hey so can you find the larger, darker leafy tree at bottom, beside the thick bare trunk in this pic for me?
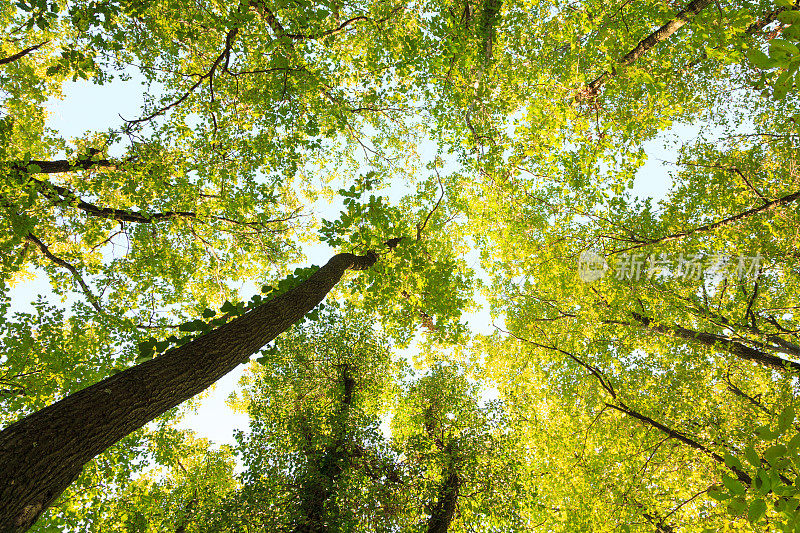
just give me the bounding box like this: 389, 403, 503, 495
214, 311, 405, 531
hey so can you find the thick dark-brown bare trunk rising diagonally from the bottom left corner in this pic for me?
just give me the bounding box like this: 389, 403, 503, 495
0, 252, 377, 533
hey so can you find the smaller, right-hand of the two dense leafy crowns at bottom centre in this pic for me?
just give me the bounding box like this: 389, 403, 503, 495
391, 366, 538, 531
